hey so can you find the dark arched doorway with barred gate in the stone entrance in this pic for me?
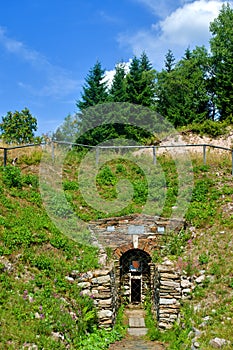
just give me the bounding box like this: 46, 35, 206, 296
120, 249, 152, 304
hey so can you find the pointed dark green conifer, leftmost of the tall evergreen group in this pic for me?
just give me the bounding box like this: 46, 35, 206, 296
76, 61, 108, 112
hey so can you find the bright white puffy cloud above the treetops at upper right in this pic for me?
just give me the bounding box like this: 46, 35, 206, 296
118, 0, 231, 69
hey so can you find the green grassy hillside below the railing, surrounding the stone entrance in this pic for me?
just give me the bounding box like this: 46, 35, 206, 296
0, 146, 233, 350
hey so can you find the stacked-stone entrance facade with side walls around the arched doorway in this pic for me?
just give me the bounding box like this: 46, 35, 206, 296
68, 215, 193, 329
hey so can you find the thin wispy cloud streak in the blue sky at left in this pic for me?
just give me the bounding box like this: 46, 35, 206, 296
0, 27, 80, 98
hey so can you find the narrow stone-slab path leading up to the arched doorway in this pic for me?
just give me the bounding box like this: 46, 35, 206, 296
109, 306, 166, 350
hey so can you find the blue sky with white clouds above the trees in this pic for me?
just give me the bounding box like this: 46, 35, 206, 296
0, 0, 232, 135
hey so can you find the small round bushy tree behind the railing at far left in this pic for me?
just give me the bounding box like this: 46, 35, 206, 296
0, 108, 37, 144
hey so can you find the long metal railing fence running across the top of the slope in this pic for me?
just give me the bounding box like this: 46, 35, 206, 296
0, 141, 233, 176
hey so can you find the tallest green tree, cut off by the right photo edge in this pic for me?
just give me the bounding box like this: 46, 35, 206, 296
210, 3, 233, 120
